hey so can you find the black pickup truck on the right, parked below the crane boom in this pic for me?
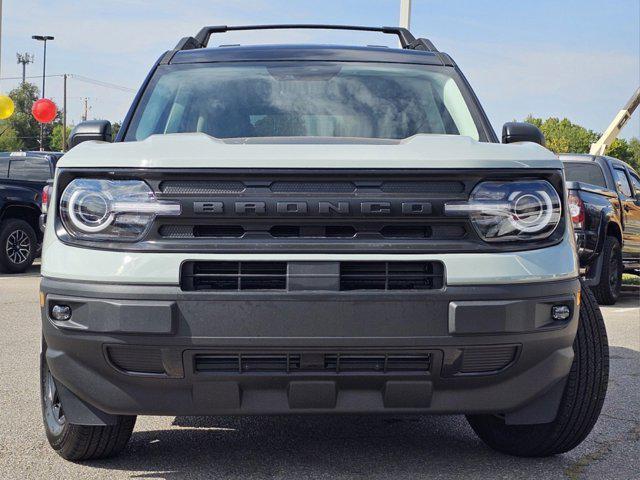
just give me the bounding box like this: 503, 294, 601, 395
560, 155, 640, 305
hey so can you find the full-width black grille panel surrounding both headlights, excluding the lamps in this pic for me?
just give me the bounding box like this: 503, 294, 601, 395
56, 168, 566, 254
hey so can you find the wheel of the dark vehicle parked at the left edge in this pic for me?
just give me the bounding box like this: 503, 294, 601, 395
0, 218, 38, 273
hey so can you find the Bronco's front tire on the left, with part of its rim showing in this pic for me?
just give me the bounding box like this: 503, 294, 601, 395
40, 354, 136, 461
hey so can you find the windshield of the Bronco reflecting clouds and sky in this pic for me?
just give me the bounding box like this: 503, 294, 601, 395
125, 62, 479, 140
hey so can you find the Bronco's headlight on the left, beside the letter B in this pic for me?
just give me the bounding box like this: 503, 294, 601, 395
60, 178, 180, 241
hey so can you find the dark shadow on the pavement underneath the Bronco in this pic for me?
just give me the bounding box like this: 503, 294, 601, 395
82, 416, 561, 479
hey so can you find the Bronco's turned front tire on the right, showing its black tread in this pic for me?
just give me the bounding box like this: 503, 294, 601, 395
467, 285, 609, 457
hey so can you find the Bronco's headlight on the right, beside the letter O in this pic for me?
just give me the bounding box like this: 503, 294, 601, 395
445, 180, 562, 242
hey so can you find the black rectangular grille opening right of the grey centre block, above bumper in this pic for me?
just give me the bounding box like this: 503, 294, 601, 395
340, 262, 444, 290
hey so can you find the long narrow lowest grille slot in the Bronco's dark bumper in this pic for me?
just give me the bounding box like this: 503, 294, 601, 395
194, 353, 431, 374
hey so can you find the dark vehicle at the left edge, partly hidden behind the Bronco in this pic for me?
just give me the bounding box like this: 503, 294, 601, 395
0, 152, 62, 273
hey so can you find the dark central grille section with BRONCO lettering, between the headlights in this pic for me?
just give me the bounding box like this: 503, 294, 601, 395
149, 170, 480, 253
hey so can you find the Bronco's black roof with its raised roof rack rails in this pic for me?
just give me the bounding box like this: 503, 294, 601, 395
160, 24, 455, 66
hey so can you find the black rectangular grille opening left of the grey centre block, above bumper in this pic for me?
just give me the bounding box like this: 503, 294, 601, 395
180, 262, 287, 291
